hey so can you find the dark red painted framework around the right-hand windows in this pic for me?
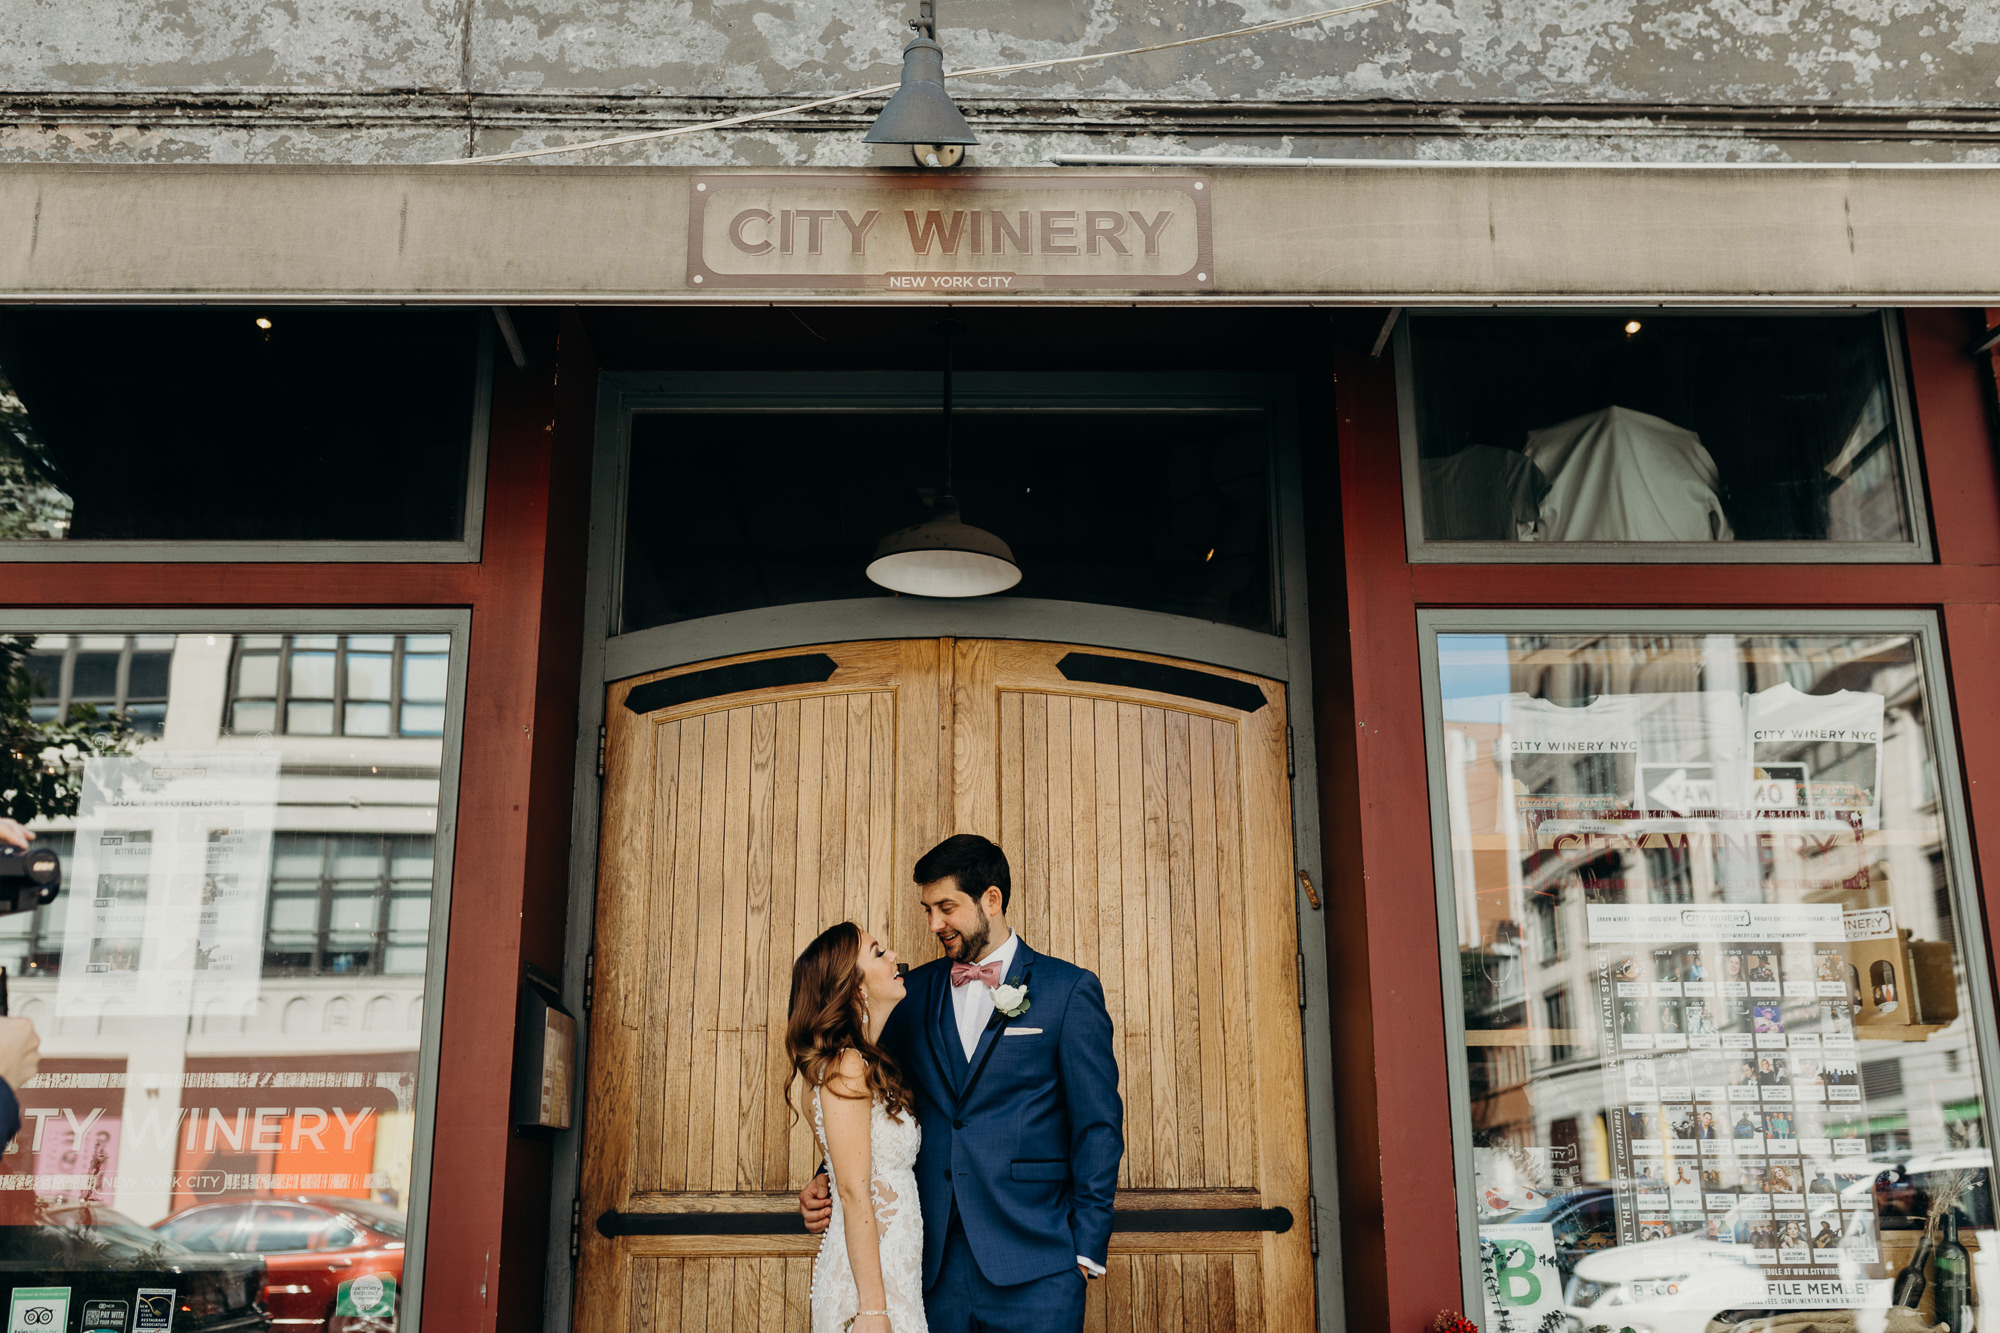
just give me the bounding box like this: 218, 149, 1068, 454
1314, 310, 2000, 1333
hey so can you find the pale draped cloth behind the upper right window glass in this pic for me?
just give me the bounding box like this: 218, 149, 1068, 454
1522, 406, 1736, 542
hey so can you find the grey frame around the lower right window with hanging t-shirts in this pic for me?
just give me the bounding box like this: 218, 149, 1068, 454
1416, 606, 2000, 1309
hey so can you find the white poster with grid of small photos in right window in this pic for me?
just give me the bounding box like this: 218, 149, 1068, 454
1586, 903, 1888, 1309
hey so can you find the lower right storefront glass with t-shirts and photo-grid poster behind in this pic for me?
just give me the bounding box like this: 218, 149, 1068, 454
1430, 612, 2000, 1331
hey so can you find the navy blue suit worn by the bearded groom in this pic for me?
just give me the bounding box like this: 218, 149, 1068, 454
882, 928, 1124, 1329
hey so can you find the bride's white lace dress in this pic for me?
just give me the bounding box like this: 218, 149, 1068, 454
812, 1089, 928, 1333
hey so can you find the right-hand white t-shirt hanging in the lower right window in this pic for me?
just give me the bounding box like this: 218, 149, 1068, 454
1744, 683, 1886, 827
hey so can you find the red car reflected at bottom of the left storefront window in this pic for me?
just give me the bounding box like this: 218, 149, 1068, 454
154, 1195, 402, 1333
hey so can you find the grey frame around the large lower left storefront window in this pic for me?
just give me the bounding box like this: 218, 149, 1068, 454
0, 606, 472, 1309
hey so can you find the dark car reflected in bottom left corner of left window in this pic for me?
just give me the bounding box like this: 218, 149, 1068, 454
0, 1203, 270, 1333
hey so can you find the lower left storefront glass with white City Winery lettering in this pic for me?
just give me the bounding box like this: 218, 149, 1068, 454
0, 624, 452, 1333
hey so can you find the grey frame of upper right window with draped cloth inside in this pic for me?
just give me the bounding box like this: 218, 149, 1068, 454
1392, 304, 1936, 564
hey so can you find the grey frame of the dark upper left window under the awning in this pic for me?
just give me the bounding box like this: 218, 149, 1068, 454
0, 316, 494, 564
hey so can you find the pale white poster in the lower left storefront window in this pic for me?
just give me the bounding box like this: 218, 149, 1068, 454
56, 753, 278, 1017
